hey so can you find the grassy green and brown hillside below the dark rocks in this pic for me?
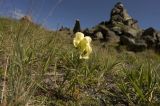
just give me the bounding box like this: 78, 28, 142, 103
0, 18, 160, 106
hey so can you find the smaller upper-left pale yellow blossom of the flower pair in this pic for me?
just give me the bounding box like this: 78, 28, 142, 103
73, 32, 84, 47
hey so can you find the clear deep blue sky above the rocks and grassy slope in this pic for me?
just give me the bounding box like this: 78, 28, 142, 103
0, 0, 160, 30
